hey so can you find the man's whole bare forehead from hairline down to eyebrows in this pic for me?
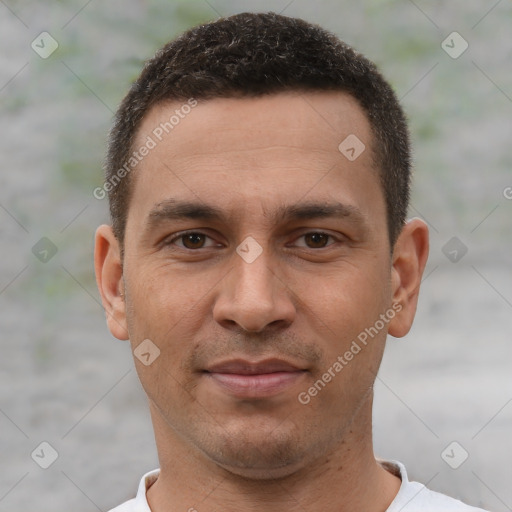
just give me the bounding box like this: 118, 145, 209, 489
129, 92, 382, 234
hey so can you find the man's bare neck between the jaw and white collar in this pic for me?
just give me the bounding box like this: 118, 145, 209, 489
147, 398, 400, 512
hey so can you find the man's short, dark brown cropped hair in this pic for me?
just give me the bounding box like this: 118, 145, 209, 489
105, 12, 411, 247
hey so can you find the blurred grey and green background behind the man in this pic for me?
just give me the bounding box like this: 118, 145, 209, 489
0, 0, 512, 512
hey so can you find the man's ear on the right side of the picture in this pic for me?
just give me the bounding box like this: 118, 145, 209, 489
388, 218, 429, 338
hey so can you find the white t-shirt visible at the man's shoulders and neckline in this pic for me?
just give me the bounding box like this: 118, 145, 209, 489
109, 461, 486, 512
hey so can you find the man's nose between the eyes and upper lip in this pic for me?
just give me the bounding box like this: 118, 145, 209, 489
213, 243, 296, 332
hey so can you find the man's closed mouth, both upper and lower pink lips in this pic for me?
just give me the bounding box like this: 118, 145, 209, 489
204, 359, 306, 398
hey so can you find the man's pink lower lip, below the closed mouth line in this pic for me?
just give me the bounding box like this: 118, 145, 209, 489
207, 371, 304, 398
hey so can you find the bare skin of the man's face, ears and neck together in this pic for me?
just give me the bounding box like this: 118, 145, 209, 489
95, 92, 428, 512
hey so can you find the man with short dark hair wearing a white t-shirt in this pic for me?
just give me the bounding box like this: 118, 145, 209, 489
95, 13, 488, 512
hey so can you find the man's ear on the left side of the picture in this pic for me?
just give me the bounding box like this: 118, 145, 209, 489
94, 224, 129, 340
